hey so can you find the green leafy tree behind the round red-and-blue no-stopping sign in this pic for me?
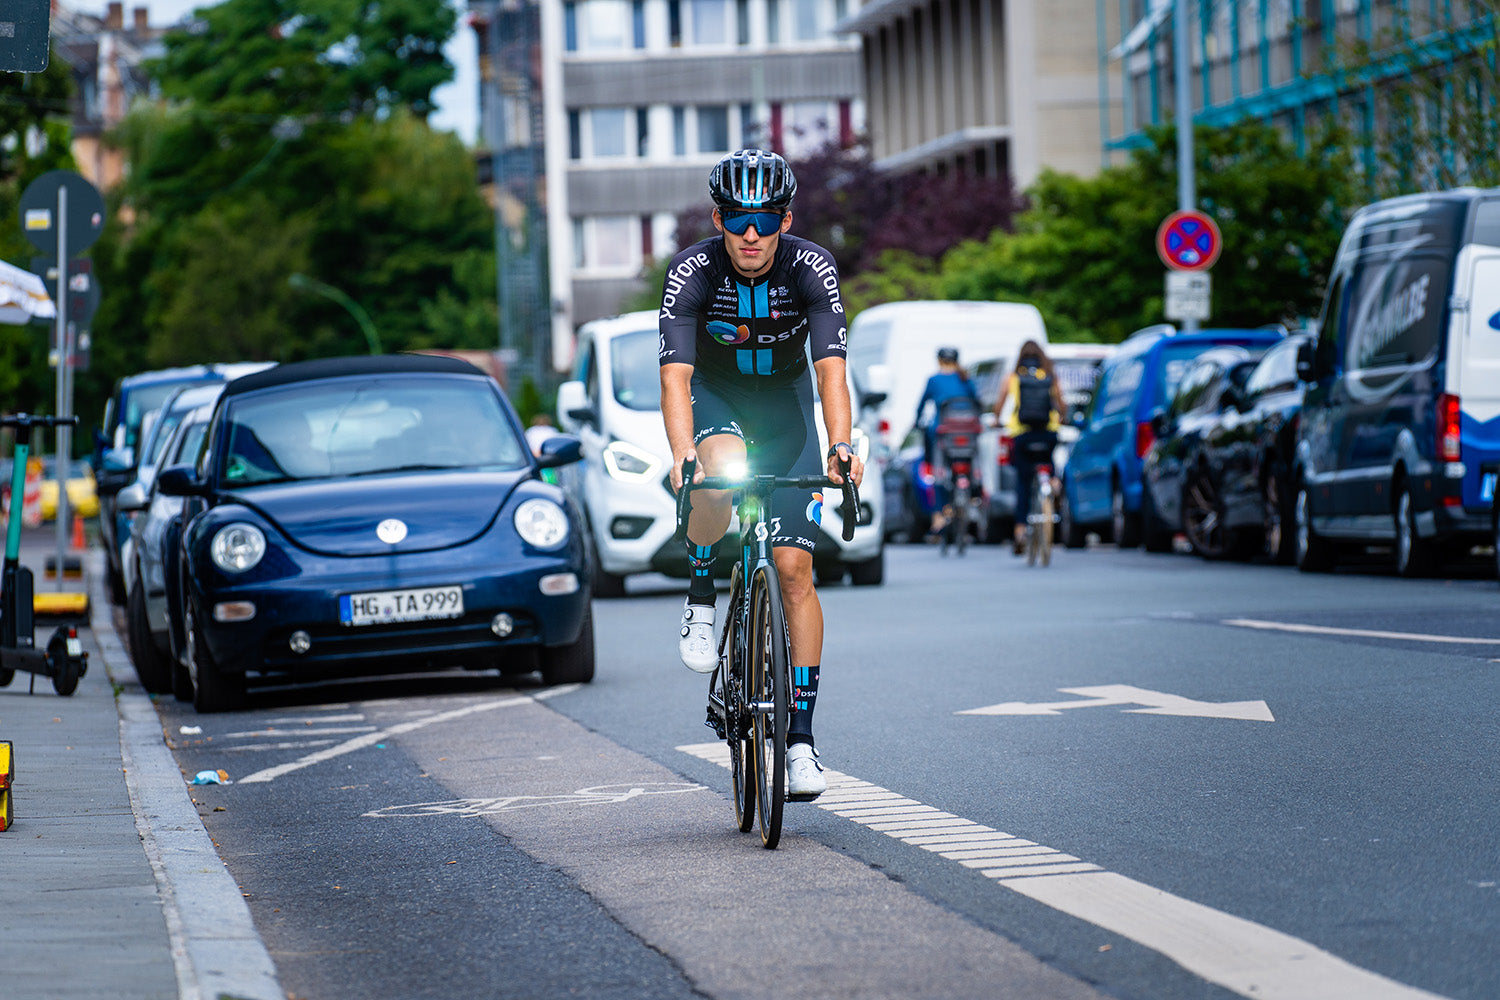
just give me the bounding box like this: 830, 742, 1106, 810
941, 123, 1358, 343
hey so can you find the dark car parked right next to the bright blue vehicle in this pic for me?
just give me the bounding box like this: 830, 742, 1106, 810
1140, 346, 1272, 559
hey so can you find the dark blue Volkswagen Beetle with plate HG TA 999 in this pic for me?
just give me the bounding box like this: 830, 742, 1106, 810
158, 354, 594, 712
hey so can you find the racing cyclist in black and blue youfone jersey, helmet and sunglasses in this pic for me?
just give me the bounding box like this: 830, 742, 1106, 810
660, 150, 864, 798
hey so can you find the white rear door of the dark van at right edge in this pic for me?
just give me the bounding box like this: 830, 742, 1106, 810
1446, 244, 1500, 508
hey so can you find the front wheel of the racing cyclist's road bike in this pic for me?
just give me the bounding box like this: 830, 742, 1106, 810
746, 565, 792, 850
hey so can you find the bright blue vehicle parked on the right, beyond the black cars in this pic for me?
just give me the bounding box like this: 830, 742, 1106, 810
1058, 324, 1286, 549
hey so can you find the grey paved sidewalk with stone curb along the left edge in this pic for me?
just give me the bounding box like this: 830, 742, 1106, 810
0, 528, 285, 1000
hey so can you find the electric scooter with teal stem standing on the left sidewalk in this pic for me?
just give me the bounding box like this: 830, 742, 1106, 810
0, 414, 89, 697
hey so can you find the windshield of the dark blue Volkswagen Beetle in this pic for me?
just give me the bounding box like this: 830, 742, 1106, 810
221, 376, 530, 486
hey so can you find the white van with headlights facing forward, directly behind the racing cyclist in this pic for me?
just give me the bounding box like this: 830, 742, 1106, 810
557, 310, 885, 597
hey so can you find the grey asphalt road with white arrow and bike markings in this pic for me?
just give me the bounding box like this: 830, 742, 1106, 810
149, 546, 1500, 1000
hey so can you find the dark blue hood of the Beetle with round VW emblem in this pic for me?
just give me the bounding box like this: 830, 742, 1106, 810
222, 469, 531, 556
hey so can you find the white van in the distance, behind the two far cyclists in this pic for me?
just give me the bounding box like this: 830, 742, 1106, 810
849, 301, 1047, 540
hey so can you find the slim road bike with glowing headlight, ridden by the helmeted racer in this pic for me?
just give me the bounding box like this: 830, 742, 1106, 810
677, 459, 860, 849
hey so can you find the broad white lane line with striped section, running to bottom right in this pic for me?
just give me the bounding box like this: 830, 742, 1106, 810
678, 741, 1442, 1000
